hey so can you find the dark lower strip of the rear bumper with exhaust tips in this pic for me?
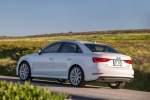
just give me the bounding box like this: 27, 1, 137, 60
97, 76, 133, 82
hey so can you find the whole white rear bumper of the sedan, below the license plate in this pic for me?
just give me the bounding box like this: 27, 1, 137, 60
85, 67, 134, 82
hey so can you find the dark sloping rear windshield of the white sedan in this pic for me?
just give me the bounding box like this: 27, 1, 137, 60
84, 44, 119, 53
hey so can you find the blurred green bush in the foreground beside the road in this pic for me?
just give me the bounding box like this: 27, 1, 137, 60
0, 81, 67, 100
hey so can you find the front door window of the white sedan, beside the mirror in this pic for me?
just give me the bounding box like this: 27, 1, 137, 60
42, 42, 62, 53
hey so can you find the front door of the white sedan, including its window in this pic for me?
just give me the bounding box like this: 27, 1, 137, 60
32, 42, 62, 76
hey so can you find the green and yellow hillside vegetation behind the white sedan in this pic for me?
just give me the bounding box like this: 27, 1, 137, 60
0, 30, 150, 91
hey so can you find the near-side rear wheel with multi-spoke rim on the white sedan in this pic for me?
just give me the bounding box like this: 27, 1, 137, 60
69, 66, 86, 87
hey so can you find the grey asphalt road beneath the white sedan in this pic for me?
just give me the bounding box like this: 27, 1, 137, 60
0, 76, 150, 100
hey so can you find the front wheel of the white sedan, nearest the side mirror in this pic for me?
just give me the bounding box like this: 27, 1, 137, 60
18, 62, 33, 81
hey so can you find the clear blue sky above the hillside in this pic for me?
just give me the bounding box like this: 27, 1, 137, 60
0, 0, 150, 36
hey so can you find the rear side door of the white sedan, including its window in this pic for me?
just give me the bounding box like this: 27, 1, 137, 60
53, 42, 81, 77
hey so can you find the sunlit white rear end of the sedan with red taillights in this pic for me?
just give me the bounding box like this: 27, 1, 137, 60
92, 53, 134, 82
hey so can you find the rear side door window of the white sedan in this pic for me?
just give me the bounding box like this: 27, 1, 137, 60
61, 43, 82, 53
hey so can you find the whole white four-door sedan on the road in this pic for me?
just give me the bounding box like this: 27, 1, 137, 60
16, 40, 134, 89
